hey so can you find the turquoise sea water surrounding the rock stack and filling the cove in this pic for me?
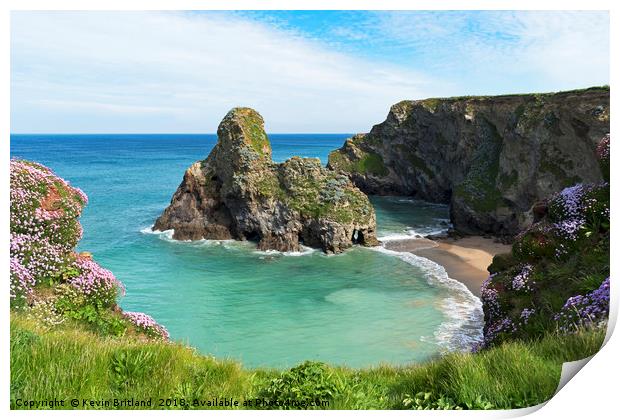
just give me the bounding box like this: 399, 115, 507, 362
11, 134, 481, 367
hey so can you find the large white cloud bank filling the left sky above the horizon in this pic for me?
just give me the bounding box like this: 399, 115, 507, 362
11, 12, 436, 132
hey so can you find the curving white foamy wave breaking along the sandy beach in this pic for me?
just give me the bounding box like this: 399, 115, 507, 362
372, 246, 484, 352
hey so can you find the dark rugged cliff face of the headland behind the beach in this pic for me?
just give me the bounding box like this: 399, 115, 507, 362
328, 87, 609, 235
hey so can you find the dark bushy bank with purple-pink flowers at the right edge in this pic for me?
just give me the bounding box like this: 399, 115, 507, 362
482, 135, 610, 347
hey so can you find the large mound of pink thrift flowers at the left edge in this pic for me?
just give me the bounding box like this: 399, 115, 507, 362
10, 159, 123, 302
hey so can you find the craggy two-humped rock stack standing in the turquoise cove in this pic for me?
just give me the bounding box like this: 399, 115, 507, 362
153, 108, 377, 253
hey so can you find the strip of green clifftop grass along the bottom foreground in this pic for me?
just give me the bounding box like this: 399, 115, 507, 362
11, 313, 604, 409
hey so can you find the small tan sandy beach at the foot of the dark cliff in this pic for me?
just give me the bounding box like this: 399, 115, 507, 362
384, 236, 511, 297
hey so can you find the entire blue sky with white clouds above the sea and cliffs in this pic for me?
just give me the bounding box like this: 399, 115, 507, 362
11, 11, 609, 133
